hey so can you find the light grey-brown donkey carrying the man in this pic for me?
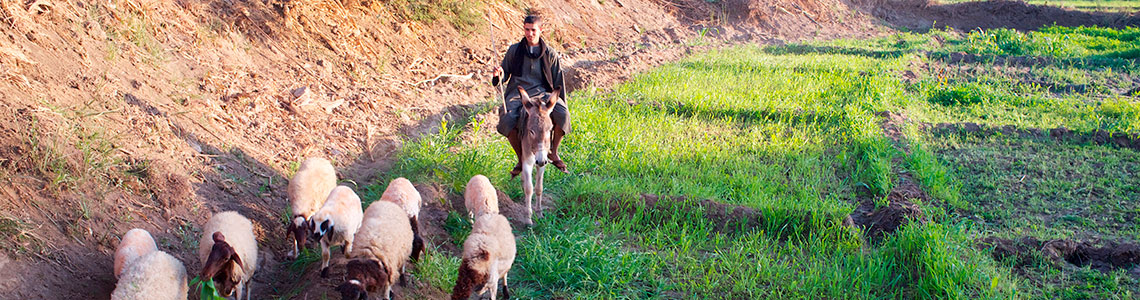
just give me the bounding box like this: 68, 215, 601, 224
519, 87, 562, 226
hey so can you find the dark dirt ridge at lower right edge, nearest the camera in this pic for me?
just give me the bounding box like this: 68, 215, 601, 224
977, 236, 1140, 271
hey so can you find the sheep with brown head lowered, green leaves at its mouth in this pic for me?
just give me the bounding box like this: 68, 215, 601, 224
198, 211, 258, 299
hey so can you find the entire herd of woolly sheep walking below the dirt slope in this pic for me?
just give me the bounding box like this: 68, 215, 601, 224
111, 159, 515, 299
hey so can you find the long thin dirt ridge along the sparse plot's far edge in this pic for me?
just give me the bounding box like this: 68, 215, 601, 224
923, 122, 1140, 151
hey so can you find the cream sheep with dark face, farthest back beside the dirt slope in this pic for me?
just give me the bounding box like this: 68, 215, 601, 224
287, 157, 336, 257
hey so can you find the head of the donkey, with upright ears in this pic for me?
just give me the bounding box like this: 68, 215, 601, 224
519, 87, 561, 167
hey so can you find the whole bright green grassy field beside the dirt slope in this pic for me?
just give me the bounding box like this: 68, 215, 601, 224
363, 27, 1140, 299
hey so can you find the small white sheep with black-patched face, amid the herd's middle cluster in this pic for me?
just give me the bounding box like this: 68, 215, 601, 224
310, 186, 364, 278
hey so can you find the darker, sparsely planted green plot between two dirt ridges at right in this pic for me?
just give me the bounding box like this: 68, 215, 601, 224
931, 135, 1140, 241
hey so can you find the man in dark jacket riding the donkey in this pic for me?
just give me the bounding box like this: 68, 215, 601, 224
492, 15, 570, 178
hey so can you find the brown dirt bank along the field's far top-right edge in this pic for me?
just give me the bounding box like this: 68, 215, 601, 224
855, 0, 1140, 31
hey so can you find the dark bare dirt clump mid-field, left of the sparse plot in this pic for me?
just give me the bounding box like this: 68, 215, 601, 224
845, 175, 930, 241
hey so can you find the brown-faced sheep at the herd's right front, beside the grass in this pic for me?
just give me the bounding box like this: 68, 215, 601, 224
451, 214, 515, 300
